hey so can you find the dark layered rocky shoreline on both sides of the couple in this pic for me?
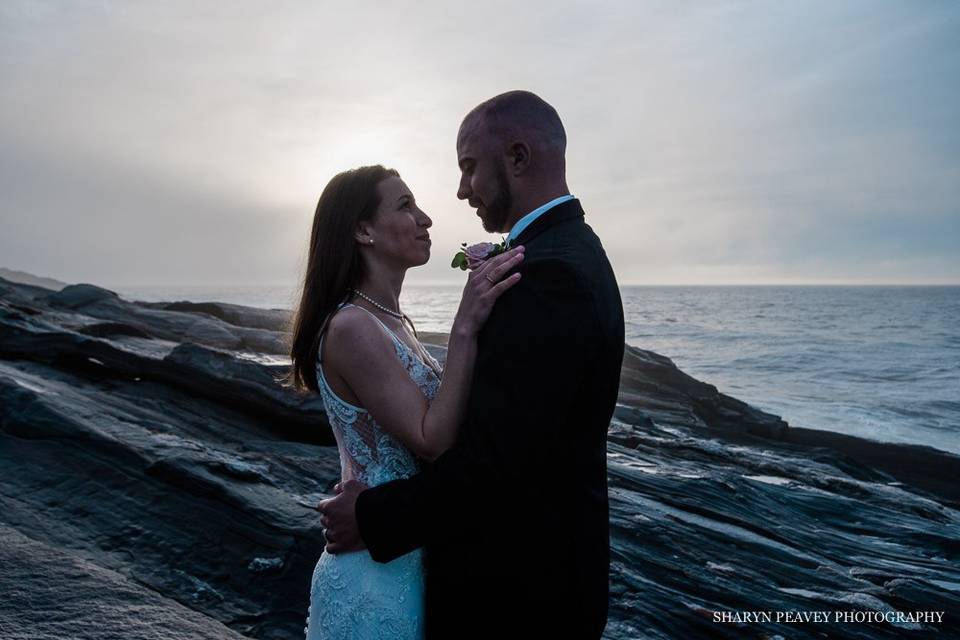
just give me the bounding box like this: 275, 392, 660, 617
0, 279, 960, 639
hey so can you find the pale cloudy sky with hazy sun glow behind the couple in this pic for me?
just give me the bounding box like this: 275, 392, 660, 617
0, 0, 960, 287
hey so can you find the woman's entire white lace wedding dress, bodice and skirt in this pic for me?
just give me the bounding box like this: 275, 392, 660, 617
304, 304, 440, 640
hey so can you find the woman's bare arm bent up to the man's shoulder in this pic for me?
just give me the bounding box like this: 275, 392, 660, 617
324, 247, 523, 460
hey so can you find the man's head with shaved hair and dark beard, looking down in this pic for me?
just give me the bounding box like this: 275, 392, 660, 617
457, 91, 568, 232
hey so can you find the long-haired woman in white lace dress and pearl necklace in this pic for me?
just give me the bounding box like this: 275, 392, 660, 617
291, 165, 523, 640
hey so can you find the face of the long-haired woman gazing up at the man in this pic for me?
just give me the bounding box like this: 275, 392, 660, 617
361, 177, 433, 267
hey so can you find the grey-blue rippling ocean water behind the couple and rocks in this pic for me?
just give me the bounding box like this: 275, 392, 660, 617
118, 285, 960, 454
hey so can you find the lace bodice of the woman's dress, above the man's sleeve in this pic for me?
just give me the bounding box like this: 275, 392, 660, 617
317, 304, 440, 487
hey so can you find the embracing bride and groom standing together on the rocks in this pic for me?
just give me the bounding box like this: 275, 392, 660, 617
291, 91, 624, 640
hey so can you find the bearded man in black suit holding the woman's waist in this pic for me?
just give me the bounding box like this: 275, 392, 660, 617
319, 91, 624, 639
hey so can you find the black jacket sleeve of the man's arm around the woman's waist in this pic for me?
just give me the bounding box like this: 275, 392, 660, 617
355, 259, 599, 562
